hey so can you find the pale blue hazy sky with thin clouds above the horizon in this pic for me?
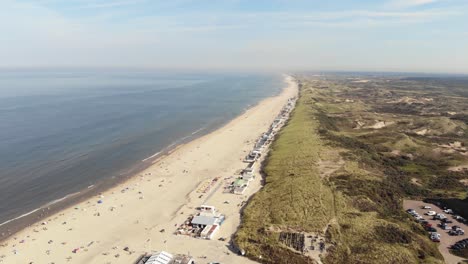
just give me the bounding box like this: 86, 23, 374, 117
0, 0, 468, 73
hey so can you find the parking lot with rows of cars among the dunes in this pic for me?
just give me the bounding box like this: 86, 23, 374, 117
403, 200, 468, 264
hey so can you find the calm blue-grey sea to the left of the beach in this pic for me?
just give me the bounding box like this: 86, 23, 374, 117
0, 70, 283, 223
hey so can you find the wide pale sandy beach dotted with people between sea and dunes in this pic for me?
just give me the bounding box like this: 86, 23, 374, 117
0, 77, 298, 264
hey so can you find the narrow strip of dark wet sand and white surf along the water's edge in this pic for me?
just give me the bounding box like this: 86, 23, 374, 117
0, 85, 282, 243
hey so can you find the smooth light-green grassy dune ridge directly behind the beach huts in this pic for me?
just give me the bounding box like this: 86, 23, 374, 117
236, 87, 334, 263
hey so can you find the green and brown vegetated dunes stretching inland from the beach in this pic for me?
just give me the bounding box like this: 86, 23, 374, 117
235, 76, 468, 263
